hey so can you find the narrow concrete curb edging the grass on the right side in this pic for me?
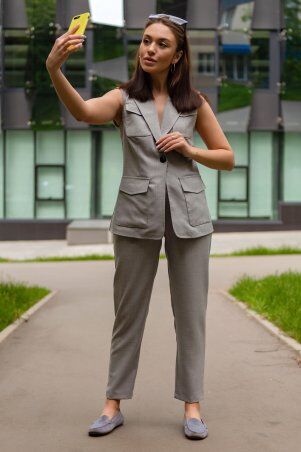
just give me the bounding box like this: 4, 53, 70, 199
219, 289, 301, 364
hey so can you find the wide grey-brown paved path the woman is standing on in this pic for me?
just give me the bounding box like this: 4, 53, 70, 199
0, 255, 301, 452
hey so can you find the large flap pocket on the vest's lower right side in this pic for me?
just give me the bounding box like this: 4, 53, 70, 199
179, 174, 211, 226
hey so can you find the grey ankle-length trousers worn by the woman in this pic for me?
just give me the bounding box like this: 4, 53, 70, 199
106, 187, 212, 403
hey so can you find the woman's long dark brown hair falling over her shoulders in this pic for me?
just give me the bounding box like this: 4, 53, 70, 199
118, 17, 210, 113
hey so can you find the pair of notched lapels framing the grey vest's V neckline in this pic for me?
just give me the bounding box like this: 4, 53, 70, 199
133, 97, 180, 141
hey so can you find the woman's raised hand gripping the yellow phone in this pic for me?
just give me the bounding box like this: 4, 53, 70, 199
46, 24, 84, 72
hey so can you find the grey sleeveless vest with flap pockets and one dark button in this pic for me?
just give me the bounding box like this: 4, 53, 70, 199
109, 89, 214, 239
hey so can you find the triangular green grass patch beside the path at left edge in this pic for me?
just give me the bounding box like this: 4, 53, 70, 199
0, 281, 51, 331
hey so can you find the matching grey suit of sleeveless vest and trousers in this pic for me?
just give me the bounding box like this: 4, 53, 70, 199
106, 90, 214, 403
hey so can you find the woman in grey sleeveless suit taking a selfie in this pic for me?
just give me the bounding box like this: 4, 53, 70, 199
46, 14, 234, 439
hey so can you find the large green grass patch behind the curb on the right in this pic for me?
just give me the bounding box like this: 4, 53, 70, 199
229, 271, 301, 343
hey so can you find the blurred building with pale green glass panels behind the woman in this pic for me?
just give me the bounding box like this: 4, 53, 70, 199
0, 0, 301, 240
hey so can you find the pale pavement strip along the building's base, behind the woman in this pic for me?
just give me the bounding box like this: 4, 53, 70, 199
0, 231, 301, 259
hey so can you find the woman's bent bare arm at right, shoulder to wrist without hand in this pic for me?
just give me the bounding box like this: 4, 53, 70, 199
192, 100, 235, 171
